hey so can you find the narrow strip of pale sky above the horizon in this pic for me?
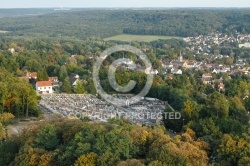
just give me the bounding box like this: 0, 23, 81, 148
0, 0, 250, 8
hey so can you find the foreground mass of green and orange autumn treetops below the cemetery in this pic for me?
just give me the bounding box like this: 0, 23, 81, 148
0, 119, 208, 166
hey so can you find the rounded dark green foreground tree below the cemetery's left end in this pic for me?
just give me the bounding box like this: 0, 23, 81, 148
35, 125, 59, 150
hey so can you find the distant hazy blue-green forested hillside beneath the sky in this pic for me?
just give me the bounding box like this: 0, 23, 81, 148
0, 9, 250, 39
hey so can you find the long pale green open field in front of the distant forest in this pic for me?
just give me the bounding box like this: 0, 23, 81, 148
104, 35, 182, 42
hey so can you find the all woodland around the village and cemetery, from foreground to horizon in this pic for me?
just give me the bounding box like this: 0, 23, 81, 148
0, 9, 250, 166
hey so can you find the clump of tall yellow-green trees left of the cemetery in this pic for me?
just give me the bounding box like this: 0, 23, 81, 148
0, 67, 39, 118
